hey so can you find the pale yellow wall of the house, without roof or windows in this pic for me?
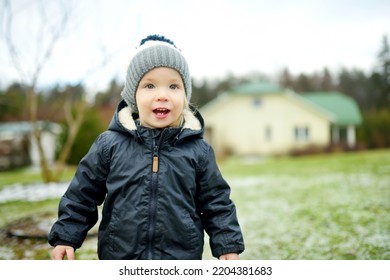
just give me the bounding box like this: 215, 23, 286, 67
202, 94, 330, 155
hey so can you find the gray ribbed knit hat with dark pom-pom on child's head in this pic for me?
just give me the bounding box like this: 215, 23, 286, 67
121, 35, 192, 113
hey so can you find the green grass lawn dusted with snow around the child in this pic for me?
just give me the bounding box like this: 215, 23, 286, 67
0, 150, 390, 260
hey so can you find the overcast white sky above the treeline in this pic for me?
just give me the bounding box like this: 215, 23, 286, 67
0, 0, 390, 91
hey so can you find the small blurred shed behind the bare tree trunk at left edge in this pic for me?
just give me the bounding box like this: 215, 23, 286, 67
0, 121, 61, 170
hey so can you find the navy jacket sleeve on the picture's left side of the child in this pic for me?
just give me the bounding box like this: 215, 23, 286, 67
48, 133, 109, 248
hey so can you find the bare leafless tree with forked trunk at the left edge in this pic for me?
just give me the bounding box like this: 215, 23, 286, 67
2, 0, 87, 182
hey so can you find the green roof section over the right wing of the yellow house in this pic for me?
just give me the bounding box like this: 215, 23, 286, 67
301, 92, 362, 125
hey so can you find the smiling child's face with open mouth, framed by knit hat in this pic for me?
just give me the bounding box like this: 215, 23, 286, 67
135, 67, 185, 128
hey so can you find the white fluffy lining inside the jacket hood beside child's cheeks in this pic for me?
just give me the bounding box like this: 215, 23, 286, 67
118, 106, 202, 130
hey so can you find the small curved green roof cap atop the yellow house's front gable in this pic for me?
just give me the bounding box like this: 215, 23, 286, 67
228, 81, 285, 95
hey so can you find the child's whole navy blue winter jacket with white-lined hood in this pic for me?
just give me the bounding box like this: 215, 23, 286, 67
49, 101, 244, 260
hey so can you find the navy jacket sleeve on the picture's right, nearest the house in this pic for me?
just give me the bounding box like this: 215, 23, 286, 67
197, 145, 245, 258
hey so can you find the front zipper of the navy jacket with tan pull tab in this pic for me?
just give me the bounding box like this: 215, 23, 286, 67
147, 140, 159, 260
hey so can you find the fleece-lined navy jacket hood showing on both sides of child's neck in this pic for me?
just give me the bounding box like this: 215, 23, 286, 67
108, 100, 204, 140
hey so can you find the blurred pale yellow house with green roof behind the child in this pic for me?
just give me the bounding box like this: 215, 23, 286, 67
200, 81, 362, 156
